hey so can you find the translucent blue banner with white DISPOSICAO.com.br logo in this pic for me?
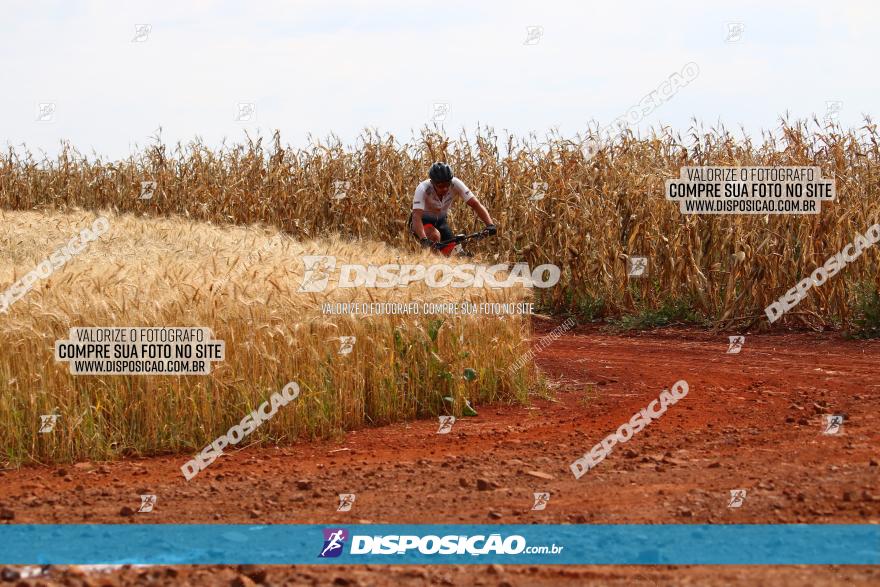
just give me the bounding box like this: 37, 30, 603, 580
0, 524, 880, 565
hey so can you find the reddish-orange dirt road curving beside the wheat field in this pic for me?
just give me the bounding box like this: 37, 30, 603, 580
0, 324, 880, 585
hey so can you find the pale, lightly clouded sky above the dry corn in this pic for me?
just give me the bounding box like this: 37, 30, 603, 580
0, 0, 880, 157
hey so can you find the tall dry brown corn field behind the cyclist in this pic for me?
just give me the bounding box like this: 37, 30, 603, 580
0, 121, 880, 328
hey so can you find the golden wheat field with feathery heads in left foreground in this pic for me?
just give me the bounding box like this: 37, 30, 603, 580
0, 210, 535, 463
